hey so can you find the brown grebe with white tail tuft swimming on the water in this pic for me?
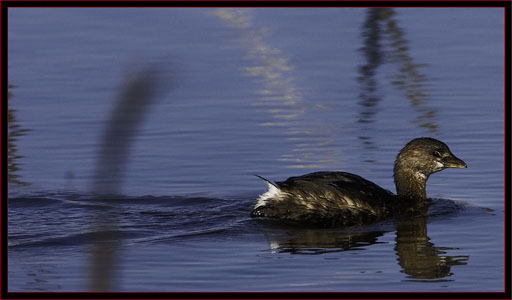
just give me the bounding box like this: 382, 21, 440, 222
251, 138, 466, 225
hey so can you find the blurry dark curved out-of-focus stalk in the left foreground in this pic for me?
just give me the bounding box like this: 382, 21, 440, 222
89, 69, 156, 291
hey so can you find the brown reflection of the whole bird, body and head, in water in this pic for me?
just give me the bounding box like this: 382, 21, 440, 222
267, 210, 469, 280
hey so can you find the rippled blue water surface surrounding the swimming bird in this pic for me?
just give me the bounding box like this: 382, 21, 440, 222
8, 8, 504, 292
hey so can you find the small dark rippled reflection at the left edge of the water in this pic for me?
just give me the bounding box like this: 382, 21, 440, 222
7, 85, 30, 186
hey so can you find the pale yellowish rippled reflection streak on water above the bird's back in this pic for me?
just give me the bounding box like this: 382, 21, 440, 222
214, 8, 333, 168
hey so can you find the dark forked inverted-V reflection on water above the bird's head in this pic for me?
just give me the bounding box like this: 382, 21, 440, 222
358, 8, 437, 133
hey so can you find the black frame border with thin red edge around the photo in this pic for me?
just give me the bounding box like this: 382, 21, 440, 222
0, 0, 511, 299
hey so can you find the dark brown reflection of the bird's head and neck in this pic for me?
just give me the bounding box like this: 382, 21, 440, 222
395, 216, 469, 279
